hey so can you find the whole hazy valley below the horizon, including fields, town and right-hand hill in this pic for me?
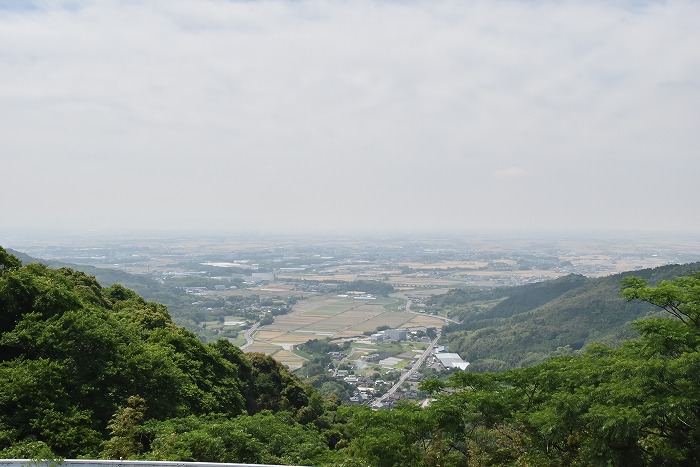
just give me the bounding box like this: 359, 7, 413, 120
6, 234, 700, 403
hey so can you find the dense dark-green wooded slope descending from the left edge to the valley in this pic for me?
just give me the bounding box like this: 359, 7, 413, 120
0, 248, 317, 457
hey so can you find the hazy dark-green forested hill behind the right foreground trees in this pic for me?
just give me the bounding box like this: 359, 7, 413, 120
430, 263, 700, 371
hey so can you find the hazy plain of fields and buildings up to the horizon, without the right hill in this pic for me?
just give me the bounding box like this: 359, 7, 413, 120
12, 235, 700, 408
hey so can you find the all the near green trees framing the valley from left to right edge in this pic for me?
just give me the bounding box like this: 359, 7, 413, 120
0, 248, 700, 467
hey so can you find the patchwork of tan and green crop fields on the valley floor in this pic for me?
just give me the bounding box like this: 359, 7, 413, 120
246, 295, 443, 369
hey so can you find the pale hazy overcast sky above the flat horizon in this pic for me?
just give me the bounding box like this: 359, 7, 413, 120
0, 0, 700, 238
